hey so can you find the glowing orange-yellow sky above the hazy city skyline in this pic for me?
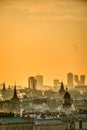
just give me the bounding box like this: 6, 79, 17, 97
0, 0, 87, 86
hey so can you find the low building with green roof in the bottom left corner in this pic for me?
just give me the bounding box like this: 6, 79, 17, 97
0, 117, 33, 130
